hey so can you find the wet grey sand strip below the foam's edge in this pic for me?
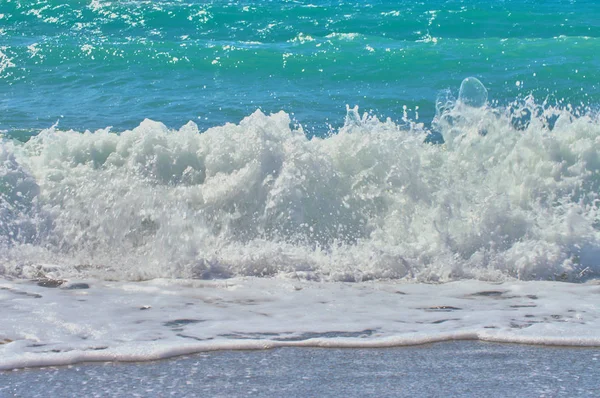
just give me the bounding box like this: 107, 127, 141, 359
0, 341, 600, 398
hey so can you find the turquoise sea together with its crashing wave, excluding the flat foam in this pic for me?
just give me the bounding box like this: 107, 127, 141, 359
0, 0, 600, 281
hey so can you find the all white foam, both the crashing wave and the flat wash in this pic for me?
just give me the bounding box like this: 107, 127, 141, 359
0, 97, 600, 369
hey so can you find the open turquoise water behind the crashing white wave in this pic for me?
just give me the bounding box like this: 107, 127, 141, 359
0, 0, 600, 136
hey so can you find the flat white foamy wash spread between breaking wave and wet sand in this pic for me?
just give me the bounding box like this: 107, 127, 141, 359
0, 278, 600, 370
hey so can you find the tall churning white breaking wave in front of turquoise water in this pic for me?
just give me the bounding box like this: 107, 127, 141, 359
0, 95, 600, 281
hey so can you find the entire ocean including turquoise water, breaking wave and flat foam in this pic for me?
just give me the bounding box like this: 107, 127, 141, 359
0, 0, 600, 370
